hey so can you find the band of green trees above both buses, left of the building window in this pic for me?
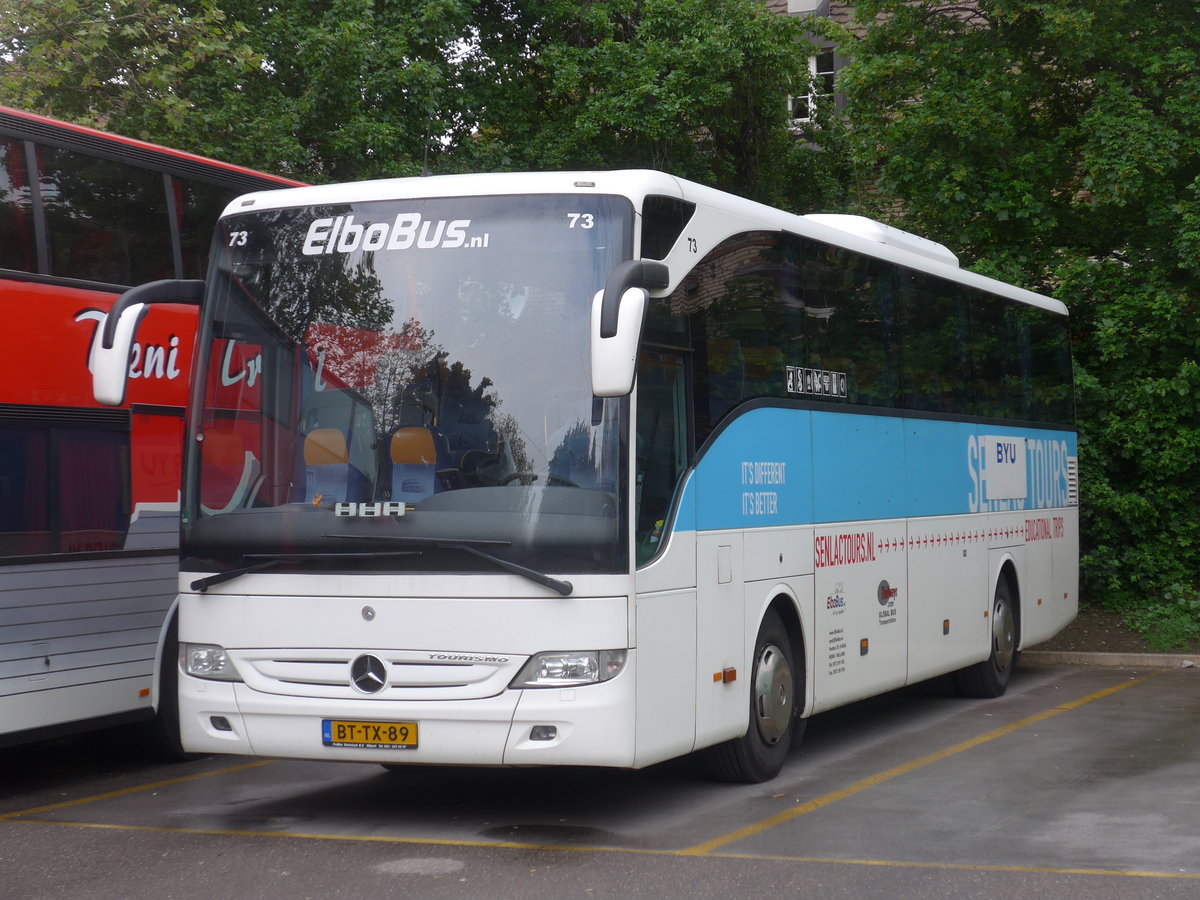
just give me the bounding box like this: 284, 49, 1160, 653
0, 0, 846, 211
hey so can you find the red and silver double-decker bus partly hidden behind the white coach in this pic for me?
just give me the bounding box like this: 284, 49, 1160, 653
0, 107, 299, 746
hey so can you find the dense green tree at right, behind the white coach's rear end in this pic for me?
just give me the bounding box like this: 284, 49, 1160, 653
842, 0, 1200, 644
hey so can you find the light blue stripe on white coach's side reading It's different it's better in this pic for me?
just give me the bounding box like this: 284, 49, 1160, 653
676, 407, 1078, 530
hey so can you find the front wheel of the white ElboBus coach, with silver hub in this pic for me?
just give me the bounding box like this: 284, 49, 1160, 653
704, 610, 803, 784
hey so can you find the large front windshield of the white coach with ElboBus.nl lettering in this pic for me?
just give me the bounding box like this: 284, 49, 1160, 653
182, 196, 632, 572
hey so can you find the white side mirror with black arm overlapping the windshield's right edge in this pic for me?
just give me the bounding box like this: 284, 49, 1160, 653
592, 259, 671, 397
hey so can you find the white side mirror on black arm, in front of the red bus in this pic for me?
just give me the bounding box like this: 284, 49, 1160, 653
88, 278, 204, 407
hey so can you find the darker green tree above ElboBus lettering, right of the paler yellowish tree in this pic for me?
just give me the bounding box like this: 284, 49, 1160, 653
185, 0, 472, 181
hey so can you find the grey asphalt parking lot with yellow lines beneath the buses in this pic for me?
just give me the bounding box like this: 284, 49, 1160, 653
0, 654, 1200, 899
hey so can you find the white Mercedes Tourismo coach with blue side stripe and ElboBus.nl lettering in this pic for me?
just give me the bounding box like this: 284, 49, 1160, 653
96, 172, 1079, 781
